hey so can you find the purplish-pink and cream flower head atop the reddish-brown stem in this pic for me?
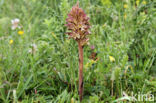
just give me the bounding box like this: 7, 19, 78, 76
66, 3, 90, 46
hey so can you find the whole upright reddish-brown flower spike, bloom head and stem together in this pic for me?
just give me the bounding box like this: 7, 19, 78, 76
66, 3, 90, 101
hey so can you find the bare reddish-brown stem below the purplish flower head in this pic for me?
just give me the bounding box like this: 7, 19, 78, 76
78, 41, 83, 102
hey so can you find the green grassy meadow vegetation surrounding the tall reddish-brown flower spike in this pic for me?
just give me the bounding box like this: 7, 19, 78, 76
0, 0, 156, 103
